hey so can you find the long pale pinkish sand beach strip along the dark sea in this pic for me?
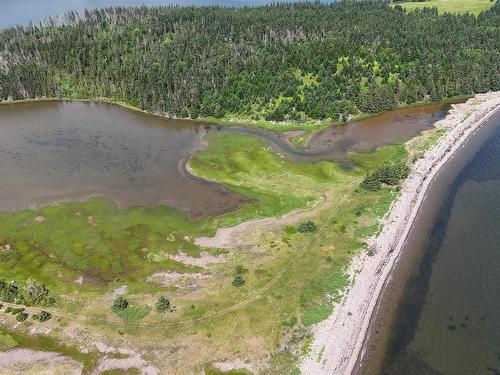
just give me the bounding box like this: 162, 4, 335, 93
301, 92, 500, 375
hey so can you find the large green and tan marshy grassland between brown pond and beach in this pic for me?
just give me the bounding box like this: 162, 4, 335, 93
0, 122, 420, 374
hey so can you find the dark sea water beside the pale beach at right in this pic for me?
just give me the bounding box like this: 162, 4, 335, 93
383, 112, 500, 375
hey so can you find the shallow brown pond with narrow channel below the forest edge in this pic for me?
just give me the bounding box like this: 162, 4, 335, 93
0, 101, 456, 219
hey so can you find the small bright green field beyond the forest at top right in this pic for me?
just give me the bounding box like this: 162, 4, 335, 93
397, 0, 494, 15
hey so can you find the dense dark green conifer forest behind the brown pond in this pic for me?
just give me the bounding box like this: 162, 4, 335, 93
0, 1, 500, 121
